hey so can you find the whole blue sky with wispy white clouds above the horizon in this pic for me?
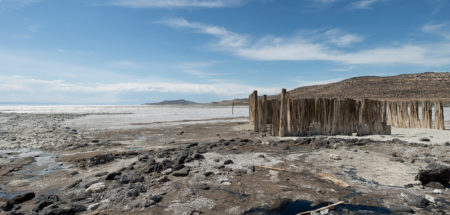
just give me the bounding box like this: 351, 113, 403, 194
0, 0, 450, 105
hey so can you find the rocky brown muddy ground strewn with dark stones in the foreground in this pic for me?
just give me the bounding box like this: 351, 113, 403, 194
0, 113, 450, 214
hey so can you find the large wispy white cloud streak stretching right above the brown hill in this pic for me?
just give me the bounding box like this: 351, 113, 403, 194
163, 19, 450, 66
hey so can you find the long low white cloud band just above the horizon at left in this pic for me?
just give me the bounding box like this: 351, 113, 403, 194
0, 76, 280, 100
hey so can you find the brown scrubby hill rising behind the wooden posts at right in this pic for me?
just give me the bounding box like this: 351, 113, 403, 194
289, 72, 450, 101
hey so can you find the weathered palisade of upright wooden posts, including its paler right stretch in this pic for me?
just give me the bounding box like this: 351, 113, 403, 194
249, 89, 444, 136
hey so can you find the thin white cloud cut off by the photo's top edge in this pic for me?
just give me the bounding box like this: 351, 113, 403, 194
109, 0, 244, 8
